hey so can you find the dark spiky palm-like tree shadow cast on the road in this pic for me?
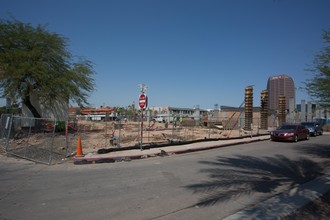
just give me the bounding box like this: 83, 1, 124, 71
186, 155, 322, 207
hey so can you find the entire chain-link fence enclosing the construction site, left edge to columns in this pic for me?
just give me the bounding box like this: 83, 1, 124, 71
0, 115, 284, 164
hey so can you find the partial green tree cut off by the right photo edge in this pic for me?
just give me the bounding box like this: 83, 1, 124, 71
305, 30, 330, 107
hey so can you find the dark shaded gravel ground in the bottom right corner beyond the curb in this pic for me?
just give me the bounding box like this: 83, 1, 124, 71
282, 192, 330, 220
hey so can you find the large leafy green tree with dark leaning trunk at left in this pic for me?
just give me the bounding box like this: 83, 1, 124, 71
0, 19, 95, 118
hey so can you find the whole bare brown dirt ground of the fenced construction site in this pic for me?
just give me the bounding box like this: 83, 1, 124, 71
3, 118, 269, 164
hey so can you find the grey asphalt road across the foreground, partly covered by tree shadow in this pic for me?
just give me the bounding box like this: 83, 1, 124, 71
0, 134, 330, 220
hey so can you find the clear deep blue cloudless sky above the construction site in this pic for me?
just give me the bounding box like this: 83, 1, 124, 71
0, 0, 330, 109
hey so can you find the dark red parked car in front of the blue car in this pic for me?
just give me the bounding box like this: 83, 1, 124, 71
270, 124, 309, 142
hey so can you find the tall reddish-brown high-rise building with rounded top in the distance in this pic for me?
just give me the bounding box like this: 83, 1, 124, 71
267, 74, 296, 110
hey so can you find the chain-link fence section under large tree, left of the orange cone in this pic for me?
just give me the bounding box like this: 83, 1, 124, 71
0, 115, 75, 164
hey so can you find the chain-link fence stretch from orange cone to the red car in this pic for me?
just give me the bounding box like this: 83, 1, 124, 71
71, 115, 267, 153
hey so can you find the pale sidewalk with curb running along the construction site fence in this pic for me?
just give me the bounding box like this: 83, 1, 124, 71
73, 135, 270, 164
